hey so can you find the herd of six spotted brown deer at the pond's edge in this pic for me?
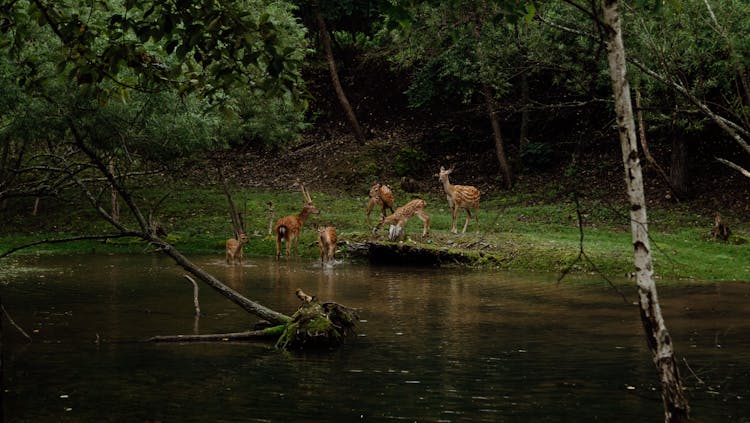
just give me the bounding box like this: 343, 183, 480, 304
226, 166, 480, 265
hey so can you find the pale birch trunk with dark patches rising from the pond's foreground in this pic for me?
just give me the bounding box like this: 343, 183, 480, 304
602, 0, 689, 422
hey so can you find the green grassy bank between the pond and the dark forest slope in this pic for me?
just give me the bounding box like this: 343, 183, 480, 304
0, 183, 750, 281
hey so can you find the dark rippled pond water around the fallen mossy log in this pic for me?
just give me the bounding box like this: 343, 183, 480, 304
0, 255, 750, 422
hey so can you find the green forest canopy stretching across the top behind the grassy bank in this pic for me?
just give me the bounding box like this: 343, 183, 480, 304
0, 0, 750, 204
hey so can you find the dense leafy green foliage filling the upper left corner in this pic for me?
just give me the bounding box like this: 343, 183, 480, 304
0, 0, 308, 208
